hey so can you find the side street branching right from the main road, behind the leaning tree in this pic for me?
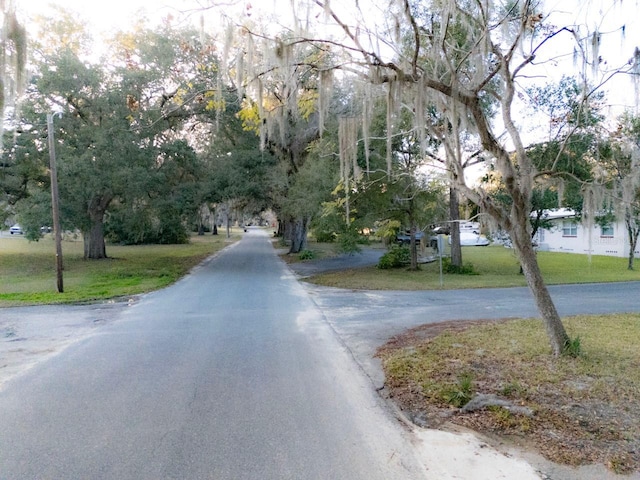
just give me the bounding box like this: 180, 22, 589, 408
306, 282, 640, 387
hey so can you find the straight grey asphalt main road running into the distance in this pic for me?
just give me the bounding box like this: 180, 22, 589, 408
0, 230, 424, 480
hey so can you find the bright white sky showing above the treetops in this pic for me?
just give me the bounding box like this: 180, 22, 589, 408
15, 0, 640, 113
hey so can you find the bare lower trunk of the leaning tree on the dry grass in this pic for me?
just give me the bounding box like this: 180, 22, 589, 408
512, 223, 569, 356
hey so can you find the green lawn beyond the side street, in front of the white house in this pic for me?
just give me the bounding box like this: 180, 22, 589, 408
309, 246, 640, 290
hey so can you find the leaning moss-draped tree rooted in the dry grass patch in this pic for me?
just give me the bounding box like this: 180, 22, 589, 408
268, 0, 636, 355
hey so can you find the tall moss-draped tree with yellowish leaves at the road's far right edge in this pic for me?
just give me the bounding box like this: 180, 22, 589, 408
236, 29, 331, 253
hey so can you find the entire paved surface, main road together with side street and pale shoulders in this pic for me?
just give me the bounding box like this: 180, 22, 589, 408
0, 229, 640, 480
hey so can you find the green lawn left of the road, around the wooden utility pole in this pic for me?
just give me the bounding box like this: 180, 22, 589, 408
0, 229, 241, 307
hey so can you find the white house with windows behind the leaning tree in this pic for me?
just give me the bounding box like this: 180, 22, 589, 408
533, 208, 640, 257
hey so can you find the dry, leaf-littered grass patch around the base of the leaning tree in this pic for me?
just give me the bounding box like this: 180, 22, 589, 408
379, 314, 640, 473
